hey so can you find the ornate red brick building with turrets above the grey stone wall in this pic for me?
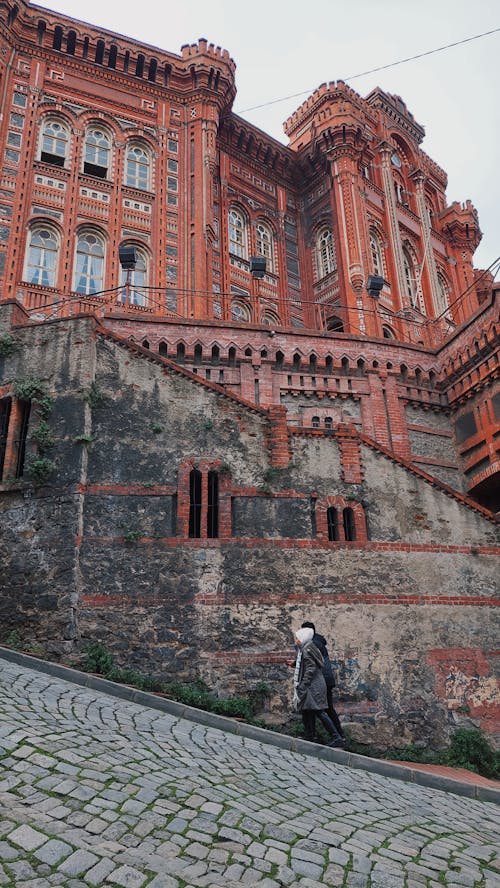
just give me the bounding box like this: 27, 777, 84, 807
0, 0, 500, 509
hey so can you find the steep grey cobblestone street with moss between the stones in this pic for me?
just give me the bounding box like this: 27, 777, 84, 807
0, 662, 500, 888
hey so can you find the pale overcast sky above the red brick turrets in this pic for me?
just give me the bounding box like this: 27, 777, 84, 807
38, 0, 500, 268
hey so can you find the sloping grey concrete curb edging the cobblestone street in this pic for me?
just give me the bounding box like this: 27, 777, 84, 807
0, 646, 500, 804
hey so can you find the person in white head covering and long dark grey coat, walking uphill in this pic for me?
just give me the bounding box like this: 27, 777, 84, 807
293, 627, 344, 747
